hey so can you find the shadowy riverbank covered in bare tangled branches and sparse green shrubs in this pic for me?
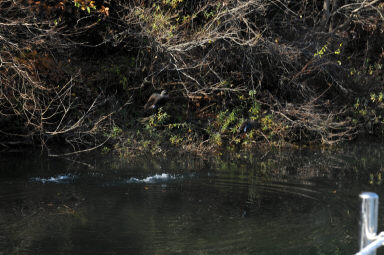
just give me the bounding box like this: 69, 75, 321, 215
0, 0, 384, 157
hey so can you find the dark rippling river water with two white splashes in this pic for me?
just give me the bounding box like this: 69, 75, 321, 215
0, 143, 384, 255
